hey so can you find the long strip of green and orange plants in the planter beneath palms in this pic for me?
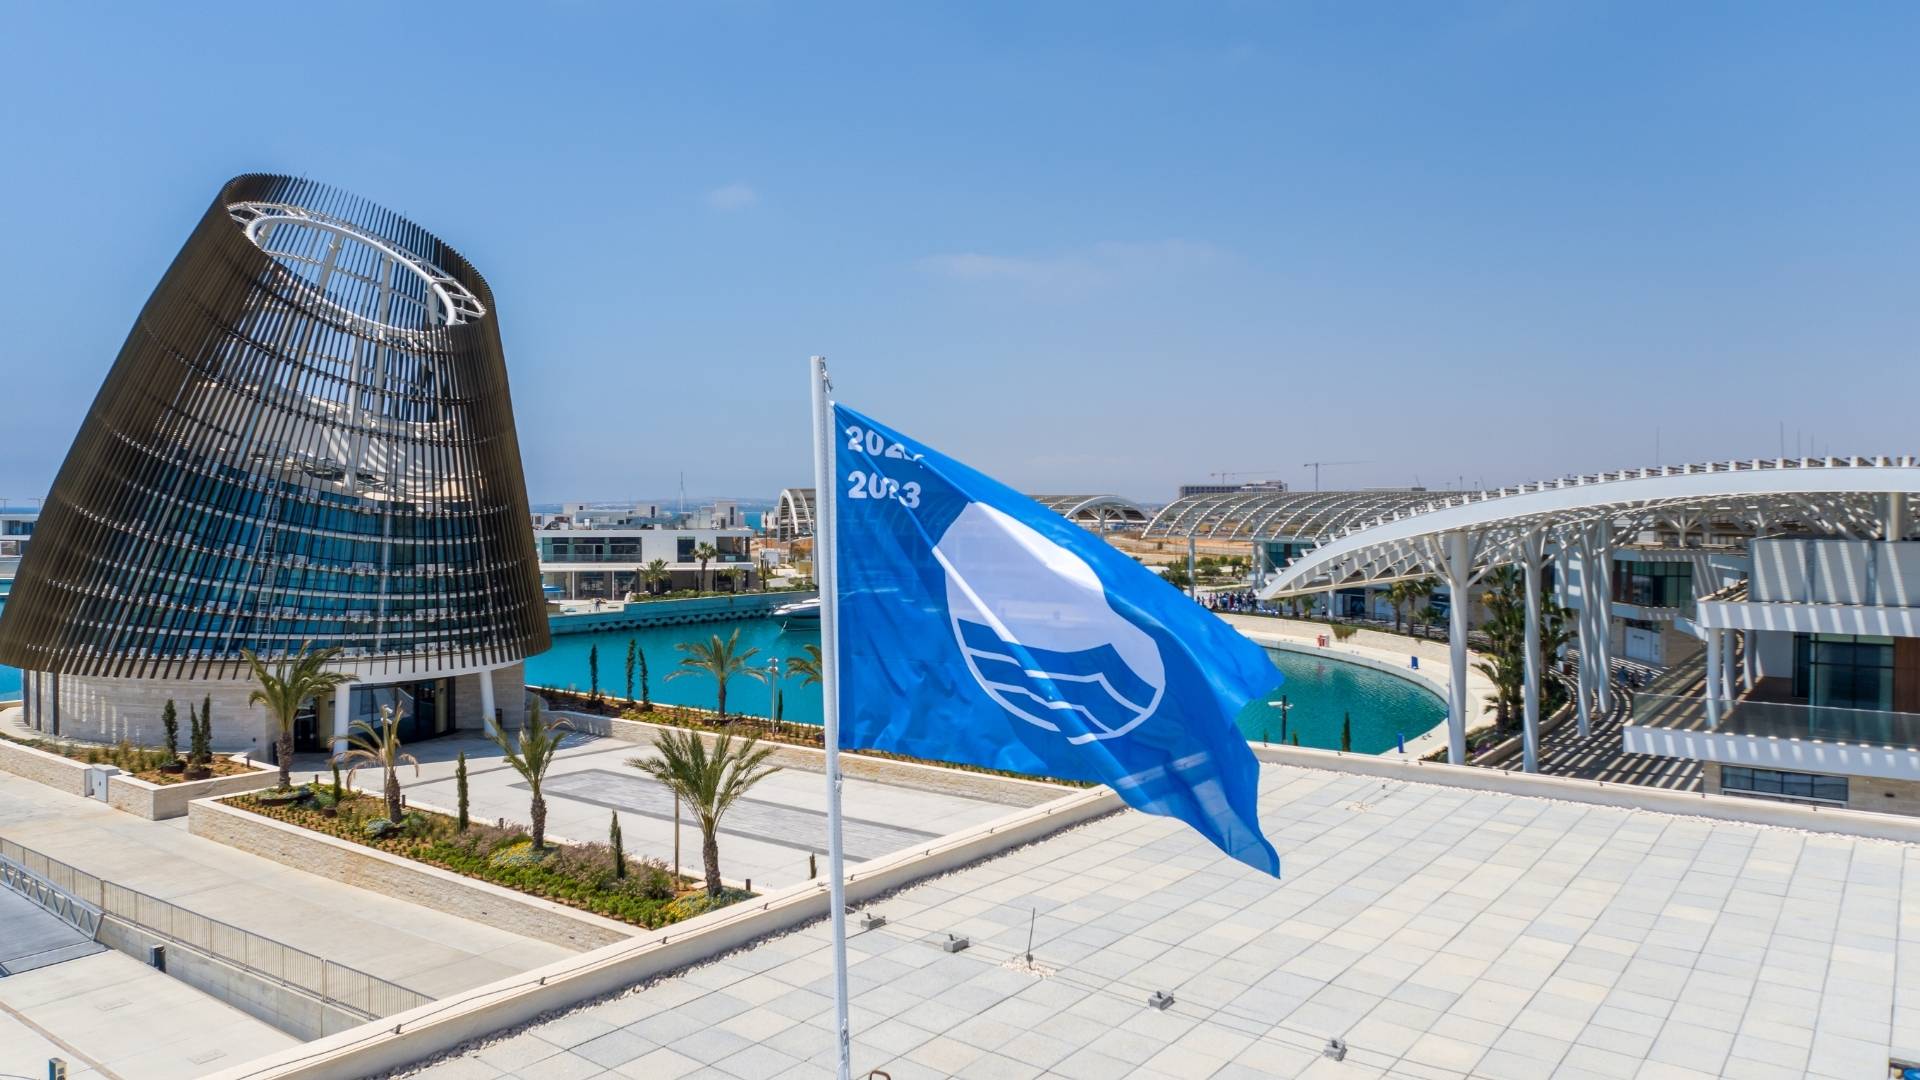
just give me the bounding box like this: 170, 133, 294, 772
225, 784, 733, 930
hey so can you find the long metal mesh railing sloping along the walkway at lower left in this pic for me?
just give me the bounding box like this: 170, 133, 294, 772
0, 838, 432, 1020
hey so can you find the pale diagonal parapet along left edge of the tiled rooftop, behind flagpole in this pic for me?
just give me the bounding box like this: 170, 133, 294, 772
202, 788, 1121, 1080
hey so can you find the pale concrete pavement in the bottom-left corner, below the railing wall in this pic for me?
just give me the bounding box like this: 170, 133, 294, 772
0, 951, 300, 1080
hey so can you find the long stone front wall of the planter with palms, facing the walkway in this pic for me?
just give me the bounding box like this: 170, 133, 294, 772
186, 799, 629, 951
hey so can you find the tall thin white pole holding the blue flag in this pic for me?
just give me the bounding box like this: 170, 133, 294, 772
812, 356, 852, 1080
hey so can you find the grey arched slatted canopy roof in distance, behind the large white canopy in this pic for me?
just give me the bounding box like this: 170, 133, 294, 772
1142, 488, 1434, 540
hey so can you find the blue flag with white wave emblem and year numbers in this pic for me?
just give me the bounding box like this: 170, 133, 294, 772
822, 405, 1281, 874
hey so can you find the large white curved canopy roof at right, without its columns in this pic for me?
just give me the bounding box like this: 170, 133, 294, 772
1261, 449, 1920, 598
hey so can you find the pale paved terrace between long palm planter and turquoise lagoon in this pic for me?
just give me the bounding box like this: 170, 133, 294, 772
296, 734, 1036, 888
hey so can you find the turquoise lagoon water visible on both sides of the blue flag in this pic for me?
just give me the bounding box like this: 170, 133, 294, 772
526, 619, 1446, 753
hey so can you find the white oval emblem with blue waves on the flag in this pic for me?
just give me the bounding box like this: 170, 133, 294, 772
933, 502, 1167, 744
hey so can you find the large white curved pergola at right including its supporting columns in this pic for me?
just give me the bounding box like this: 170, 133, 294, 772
1259, 455, 1920, 771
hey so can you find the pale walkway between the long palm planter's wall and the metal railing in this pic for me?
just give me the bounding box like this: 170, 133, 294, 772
0, 773, 566, 997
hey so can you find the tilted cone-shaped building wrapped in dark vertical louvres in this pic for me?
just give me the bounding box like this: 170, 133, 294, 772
0, 175, 549, 755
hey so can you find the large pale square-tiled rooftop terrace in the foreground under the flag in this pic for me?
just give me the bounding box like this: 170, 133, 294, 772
417, 765, 1920, 1080
